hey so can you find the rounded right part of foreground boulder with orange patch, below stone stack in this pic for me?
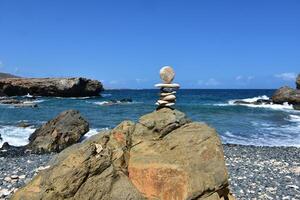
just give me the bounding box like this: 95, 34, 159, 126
128, 108, 233, 200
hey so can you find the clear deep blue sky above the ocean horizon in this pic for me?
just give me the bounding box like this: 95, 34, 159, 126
0, 0, 300, 88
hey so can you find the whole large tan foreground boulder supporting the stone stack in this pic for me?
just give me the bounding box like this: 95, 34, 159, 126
12, 108, 233, 200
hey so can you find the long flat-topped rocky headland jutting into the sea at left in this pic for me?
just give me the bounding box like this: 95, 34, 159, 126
0, 78, 103, 97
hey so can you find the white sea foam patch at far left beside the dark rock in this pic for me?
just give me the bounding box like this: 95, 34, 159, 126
0, 126, 35, 147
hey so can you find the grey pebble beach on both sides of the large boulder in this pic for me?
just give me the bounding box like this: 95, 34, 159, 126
0, 144, 300, 200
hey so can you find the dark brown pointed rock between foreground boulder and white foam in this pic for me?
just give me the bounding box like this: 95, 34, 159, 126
27, 110, 89, 153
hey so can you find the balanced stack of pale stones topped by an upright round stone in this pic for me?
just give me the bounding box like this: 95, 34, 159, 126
155, 66, 180, 109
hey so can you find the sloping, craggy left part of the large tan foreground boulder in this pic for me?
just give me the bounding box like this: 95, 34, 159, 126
12, 121, 145, 200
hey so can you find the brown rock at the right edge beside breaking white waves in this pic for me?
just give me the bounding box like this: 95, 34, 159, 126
272, 86, 300, 105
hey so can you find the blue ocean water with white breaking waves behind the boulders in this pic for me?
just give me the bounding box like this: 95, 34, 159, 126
0, 89, 300, 147
